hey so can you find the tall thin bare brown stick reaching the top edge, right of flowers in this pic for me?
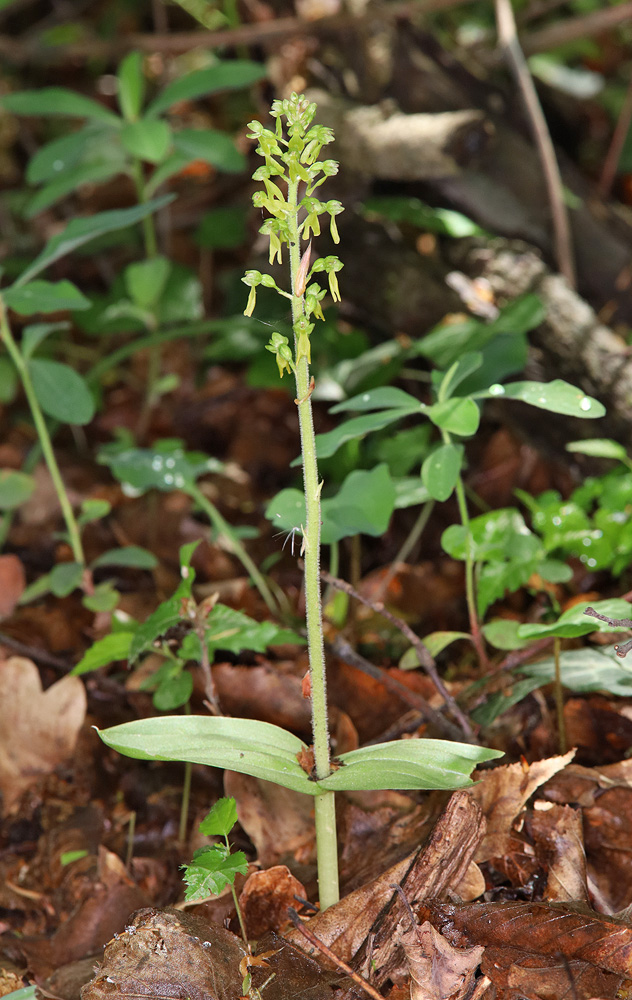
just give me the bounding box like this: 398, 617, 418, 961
495, 0, 576, 288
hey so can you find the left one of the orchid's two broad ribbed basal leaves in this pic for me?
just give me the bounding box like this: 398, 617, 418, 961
99, 715, 316, 795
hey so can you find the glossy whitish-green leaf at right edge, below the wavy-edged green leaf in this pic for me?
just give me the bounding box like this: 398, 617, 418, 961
520, 648, 632, 698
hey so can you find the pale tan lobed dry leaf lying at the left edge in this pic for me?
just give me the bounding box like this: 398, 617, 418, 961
0, 656, 86, 813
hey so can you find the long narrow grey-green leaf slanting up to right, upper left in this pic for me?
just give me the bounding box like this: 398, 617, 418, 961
11, 194, 175, 288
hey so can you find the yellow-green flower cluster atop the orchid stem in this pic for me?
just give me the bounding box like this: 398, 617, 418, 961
242, 94, 343, 375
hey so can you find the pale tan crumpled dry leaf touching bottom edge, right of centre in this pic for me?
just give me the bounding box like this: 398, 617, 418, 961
396, 920, 485, 1000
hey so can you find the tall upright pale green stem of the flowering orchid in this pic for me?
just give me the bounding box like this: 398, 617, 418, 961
287, 180, 339, 910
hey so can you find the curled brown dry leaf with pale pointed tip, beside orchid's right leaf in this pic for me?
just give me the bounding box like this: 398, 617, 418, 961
469, 750, 575, 863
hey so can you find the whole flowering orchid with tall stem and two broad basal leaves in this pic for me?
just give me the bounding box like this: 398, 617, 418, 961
100, 94, 500, 909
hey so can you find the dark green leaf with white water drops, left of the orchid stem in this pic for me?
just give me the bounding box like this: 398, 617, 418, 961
99, 441, 223, 492
